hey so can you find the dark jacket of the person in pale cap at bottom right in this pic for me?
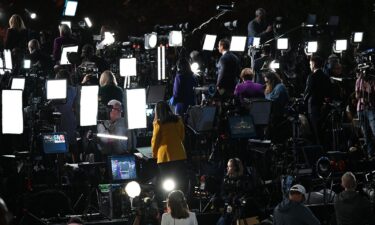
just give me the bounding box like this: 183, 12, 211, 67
273, 199, 320, 225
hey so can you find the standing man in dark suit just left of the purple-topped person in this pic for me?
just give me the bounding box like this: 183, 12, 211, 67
216, 39, 240, 95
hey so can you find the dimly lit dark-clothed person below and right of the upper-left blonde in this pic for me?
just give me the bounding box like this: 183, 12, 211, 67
28, 39, 53, 76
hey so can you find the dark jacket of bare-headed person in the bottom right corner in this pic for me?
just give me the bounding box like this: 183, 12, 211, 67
334, 191, 375, 225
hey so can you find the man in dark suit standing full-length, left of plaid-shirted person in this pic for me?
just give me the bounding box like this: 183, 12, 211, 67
304, 56, 331, 144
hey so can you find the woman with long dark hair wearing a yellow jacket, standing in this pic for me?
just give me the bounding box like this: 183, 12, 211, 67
151, 101, 186, 191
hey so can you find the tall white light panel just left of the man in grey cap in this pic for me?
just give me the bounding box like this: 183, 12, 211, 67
80, 85, 99, 126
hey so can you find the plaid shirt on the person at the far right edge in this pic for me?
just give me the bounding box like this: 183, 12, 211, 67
355, 77, 375, 111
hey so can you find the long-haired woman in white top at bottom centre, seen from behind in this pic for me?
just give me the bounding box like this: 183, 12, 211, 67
161, 190, 198, 225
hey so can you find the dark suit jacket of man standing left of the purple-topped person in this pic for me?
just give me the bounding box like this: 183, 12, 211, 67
216, 52, 240, 93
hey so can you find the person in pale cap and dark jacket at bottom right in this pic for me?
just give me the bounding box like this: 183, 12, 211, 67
273, 184, 320, 225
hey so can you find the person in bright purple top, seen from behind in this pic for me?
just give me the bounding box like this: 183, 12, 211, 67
234, 68, 264, 102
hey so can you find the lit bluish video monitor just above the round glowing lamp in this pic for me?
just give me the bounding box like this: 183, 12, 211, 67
108, 155, 138, 182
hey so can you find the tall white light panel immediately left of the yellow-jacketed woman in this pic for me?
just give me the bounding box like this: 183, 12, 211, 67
126, 88, 147, 129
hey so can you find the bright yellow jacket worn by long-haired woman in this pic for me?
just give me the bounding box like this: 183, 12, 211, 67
151, 119, 186, 163
